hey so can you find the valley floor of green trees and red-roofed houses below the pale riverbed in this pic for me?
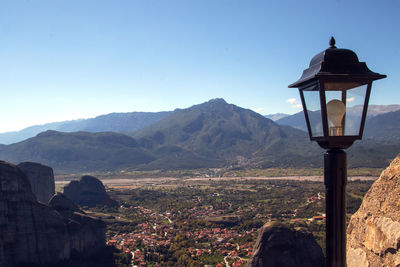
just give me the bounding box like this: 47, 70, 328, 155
87, 179, 372, 266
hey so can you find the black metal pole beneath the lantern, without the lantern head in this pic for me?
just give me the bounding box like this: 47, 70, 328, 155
324, 149, 347, 267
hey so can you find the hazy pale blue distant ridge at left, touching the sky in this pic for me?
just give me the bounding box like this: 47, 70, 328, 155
0, 112, 170, 144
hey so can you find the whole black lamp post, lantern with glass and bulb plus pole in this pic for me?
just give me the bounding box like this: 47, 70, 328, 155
289, 37, 386, 267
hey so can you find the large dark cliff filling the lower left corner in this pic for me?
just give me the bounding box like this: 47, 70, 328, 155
0, 161, 105, 267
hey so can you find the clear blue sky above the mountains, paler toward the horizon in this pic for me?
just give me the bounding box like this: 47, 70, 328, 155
0, 0, 400, 132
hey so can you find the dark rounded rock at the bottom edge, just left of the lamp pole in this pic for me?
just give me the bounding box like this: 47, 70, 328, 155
247, 223, 325, 267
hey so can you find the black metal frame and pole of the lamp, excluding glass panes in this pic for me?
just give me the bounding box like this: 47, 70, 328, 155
289, 37, 386, 267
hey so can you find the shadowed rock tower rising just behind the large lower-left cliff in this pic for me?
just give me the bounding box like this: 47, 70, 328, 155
18, 162, 55, 204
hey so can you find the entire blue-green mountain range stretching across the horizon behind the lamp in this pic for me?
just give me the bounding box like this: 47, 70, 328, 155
0, 99, 400, 173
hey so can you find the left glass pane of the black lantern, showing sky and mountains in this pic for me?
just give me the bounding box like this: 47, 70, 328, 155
303, 85, 324, 137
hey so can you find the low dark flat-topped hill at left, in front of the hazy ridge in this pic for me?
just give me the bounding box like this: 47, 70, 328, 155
0, 131, 154, 173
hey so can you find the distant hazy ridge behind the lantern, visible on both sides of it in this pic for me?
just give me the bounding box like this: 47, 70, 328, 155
276, 105, 400, 132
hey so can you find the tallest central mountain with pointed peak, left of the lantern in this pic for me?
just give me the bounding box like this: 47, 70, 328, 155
134, 99, 315, 169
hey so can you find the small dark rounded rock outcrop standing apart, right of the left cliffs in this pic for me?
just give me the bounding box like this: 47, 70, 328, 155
64, 175, 118, 207
